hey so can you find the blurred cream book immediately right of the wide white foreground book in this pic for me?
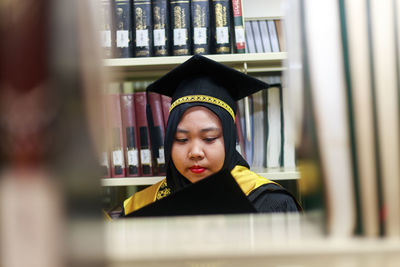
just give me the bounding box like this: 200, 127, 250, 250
343, 0, 381, 237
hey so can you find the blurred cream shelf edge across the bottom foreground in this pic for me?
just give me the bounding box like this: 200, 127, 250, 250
106, 214, 400, 267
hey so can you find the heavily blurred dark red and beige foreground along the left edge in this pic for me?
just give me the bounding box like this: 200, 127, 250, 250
0, 0, 104, 267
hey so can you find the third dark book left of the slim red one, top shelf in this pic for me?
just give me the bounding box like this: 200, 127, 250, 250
170, 0, 192, 56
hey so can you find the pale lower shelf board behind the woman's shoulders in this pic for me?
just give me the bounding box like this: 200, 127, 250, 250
101, 169, 300, 186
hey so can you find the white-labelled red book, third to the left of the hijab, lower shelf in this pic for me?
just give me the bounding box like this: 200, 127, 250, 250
121, 82, 139, 177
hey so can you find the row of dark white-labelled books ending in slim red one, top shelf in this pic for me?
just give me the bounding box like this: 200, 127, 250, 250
100, 0, 245, 58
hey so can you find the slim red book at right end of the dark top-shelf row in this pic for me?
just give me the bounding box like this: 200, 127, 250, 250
232, 0, 246, 53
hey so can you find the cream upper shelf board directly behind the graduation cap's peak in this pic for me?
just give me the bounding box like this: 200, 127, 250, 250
104, 52, 287, 80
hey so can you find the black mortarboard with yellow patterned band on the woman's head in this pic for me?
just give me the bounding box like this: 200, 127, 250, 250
147, 55, 269, 120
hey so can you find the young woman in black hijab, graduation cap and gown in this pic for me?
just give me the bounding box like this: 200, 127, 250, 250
124, 55, 301, 215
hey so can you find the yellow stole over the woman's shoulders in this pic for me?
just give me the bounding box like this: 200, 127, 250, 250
124, 165, 276, 215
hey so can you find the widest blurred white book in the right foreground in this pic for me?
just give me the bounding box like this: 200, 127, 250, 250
304, 1, 356, 237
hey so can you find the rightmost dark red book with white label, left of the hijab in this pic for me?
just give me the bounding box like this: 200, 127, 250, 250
149, 93, 165, 175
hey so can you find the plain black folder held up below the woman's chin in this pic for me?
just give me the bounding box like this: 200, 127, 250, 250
125, 170, 256, 217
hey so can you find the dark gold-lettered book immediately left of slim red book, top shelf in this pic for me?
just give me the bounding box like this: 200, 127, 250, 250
212, 0, 231, 54
